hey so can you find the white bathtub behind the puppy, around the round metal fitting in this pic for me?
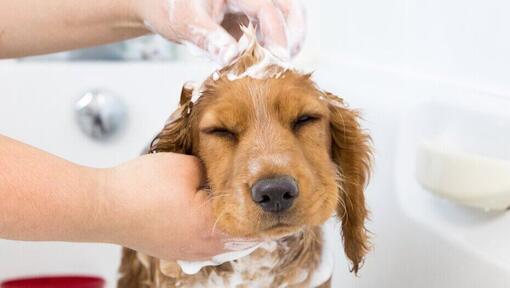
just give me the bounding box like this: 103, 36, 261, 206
0, 62, 510, 288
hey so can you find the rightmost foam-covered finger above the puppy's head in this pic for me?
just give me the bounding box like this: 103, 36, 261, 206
276, 0, 306, 56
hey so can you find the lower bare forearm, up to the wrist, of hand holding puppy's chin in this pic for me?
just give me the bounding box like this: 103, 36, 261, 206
0, 135, 105, 242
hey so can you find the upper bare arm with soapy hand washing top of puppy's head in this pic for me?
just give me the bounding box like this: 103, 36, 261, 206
0, 0, 305, 64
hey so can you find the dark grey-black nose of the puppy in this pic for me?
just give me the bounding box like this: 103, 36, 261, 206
251, 176, 299, 213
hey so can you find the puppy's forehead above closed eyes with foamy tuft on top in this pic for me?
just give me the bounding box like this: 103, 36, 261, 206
196, 27, 321, 115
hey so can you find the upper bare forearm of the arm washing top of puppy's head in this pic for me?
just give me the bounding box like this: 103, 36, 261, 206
0, 0, 149, 58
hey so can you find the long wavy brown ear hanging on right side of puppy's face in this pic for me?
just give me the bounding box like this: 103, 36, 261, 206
324, 92, 372, 273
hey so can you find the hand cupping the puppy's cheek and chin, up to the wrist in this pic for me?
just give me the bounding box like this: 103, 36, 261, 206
99, 153, 256, 260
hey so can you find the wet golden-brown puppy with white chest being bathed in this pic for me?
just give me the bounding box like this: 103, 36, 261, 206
118, 30, 371, 288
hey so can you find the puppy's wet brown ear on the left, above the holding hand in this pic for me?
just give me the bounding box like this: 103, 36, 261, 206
148, 84, 193, 154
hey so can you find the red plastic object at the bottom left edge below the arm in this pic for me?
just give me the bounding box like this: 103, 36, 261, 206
0, 276, 105, 288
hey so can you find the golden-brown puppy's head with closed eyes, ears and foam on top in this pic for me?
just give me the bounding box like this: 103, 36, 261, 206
152, 34, 370, 271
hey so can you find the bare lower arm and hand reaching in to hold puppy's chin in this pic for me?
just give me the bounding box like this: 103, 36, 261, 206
0, 135, 229, 260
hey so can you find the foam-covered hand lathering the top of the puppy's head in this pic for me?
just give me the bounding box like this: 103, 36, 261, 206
133, 0, 305, 64
